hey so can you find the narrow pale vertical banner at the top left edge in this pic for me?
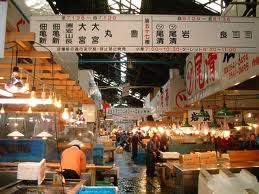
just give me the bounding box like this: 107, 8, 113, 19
0, 0, 7, 58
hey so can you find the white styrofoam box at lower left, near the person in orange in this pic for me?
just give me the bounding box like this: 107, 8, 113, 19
17, 159, 46, 185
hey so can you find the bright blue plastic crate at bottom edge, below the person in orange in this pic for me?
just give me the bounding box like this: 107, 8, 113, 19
77, 187, 118, 194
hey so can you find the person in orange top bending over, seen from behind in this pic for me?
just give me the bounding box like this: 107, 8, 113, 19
61, 145, 86, 179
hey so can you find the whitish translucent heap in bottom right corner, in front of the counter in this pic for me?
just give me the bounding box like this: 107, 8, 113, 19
199, 169, 259, 194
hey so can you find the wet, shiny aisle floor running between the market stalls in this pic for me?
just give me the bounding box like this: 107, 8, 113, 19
115, 152, 174, 194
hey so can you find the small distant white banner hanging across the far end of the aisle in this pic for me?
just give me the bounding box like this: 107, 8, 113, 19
106, 108, 150, 117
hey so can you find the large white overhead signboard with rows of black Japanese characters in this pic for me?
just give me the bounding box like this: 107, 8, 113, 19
30, 15, 259, 53
